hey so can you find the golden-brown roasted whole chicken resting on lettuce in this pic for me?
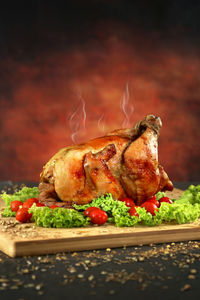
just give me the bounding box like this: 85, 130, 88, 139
39, 115, 173, 207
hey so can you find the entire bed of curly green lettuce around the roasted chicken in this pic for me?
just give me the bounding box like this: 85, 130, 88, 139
1, 185, 200, 228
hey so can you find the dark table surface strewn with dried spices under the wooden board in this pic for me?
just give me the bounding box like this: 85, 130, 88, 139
0, 181, 200, 300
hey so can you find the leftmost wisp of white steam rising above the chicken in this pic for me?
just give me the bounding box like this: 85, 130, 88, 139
69, 94, 86, 144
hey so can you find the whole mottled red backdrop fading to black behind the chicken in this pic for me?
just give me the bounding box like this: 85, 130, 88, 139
0, 0, 200, 181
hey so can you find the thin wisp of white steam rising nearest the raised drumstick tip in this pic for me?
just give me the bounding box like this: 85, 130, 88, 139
120, 83, 134, 128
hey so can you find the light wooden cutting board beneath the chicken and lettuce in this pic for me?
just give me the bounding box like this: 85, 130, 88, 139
0, 189, 200, 257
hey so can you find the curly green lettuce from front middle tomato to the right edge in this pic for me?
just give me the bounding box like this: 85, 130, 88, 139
74, 185, 200, 227
